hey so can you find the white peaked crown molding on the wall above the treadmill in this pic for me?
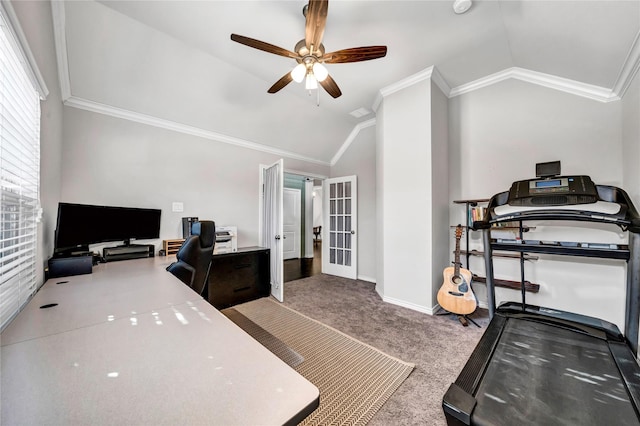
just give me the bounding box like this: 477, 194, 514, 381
449, 67, 620, 102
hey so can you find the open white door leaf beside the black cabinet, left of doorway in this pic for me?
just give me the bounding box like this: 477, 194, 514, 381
260, 160, 284, 302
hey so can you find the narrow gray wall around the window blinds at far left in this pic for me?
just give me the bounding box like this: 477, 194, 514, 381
11, 1, 63, 284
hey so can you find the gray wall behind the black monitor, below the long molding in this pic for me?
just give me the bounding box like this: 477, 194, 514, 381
61, 107, 329, 253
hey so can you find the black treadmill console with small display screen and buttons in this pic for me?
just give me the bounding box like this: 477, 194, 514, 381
508, 176, 598, 207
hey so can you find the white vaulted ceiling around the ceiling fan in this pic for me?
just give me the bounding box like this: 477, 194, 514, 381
54, 0, 640, 163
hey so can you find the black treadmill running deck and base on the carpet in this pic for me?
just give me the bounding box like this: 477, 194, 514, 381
442, 302, 640, 426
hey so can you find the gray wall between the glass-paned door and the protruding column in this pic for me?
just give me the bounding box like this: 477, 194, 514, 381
331, 126, 377, 282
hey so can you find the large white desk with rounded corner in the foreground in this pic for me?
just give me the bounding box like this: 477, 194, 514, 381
0, 257, 319, 425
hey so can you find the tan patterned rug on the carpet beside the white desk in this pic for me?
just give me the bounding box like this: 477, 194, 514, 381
222, 298, 414, 425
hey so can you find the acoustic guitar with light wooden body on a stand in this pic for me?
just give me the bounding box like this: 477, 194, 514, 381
438, 225, 478, 315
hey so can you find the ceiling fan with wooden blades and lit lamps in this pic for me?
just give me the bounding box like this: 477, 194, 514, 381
231, 0, 387, 98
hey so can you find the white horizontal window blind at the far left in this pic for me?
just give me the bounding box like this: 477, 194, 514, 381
0, 9, 40, 330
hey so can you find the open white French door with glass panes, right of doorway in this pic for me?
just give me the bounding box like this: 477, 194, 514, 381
322, 176, 358, 279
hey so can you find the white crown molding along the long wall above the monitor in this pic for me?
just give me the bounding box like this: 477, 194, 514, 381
64, 96, 330, 166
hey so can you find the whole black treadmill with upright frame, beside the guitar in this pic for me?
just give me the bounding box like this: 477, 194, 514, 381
442, 177, 640, 426
